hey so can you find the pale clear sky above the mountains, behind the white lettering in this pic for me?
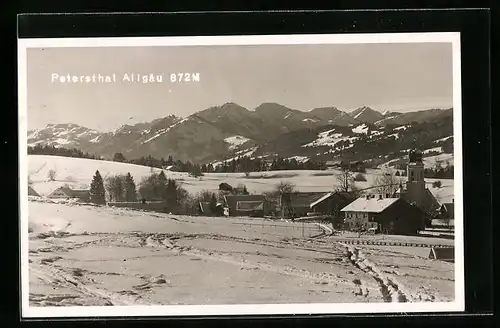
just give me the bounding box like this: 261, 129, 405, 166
27, 43, 453, 131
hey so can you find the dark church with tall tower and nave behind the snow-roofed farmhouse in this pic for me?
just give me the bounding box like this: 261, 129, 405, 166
394, 147, 441, 215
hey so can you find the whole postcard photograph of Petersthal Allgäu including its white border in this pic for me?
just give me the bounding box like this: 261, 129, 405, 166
19, 33, 464, 317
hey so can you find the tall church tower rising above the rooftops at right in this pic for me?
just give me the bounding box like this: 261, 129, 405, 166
406, 147, 426, 206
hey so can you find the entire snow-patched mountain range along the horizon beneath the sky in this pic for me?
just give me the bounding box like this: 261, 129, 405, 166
28, 103, 453, 163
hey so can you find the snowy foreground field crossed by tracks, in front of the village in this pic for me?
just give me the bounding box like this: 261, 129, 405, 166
25, 198, 454, 306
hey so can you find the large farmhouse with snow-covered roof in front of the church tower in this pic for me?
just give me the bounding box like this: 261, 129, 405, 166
341, 195, 426, 235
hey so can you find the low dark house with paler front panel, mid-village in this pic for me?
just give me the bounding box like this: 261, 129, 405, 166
224, 195, 268, 216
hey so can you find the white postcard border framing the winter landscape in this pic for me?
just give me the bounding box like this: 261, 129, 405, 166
18, 32, 465, 318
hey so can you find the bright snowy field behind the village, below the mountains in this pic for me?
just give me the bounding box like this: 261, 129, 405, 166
28, 155, 454, 202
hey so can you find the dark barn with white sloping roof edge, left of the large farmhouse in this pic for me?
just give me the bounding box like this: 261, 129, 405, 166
278, 192, 352, 217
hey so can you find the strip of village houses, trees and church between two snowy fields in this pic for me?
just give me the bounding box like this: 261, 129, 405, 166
29, 145, 454, 245
